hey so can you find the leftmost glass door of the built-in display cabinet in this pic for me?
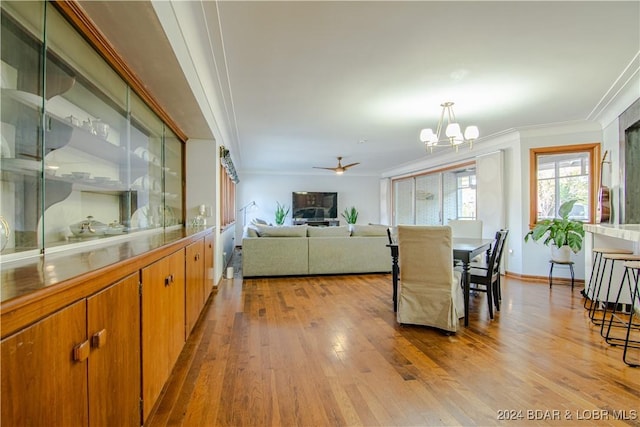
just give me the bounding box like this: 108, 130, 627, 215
0, 2, 45, 254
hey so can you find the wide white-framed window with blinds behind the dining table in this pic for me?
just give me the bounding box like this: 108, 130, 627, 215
392, 162, 476, 225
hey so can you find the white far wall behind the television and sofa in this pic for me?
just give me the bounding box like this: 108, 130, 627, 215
236, 171, 380, 246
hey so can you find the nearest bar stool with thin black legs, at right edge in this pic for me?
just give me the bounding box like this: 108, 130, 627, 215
604, 261, 640, 366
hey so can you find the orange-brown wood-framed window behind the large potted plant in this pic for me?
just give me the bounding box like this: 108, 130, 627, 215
529, 144, 600, 226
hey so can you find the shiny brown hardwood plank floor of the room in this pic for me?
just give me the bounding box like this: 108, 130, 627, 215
146, 266, 640, 426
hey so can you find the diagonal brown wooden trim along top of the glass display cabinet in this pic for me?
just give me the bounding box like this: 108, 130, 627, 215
51, 0, 187, 143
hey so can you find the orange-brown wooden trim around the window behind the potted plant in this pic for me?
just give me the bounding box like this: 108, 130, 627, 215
529, 142, 600, 229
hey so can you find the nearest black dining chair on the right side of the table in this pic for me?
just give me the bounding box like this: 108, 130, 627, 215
469, 230, 509, 319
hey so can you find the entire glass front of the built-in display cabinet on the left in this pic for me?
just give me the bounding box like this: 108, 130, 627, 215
0, 0, 184, 259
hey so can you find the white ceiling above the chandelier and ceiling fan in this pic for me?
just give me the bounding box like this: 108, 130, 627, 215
81, 1, 640, 174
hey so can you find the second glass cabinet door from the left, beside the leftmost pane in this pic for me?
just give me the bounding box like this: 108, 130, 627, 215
43, 3, 131, 247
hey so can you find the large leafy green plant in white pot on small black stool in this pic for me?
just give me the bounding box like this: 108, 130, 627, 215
524, 200, 584, 262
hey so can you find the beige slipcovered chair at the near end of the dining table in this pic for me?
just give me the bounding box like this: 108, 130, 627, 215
397, 225, 464, 332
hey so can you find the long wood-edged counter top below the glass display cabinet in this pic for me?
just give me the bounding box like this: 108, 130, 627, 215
0, 227, 213, 339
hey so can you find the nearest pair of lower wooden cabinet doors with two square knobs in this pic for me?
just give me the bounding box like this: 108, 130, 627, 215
1, 274, 140, 426
